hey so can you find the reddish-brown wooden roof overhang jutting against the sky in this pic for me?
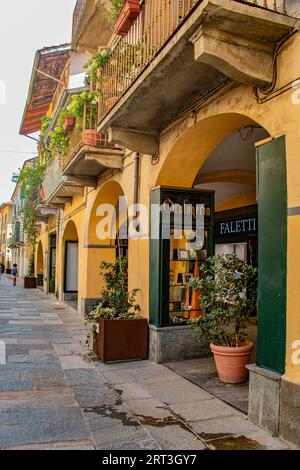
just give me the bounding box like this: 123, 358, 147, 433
20, 44, 71, 135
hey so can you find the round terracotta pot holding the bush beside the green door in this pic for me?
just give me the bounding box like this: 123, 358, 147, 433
210, 341, 253, 384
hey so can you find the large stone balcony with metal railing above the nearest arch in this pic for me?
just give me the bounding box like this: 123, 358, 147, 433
98, 0, 300, 154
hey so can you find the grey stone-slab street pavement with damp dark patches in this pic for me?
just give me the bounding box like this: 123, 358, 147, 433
0, 276, 286, 450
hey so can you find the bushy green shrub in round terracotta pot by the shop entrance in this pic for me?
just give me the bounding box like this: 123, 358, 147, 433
190, 255, 257, 384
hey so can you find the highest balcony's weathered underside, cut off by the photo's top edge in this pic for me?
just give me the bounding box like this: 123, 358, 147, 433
72, 0, 112, 53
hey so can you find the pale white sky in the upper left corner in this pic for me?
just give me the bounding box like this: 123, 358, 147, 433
0, 0, 76, 204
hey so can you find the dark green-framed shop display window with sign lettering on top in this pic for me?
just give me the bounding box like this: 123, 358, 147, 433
150, 187, 214, 327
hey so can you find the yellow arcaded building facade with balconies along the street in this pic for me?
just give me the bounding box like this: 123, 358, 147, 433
19, 0, 300, 444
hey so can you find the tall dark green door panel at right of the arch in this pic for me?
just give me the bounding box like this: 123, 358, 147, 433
256, 137, 287, 374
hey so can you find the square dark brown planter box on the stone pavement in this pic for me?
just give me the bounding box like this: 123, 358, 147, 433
93, 318, 148, 362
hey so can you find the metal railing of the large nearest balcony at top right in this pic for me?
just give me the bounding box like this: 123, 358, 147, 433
98, 0, 286, 122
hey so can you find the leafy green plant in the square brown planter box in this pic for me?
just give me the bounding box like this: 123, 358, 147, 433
84, 258, 148, 362
